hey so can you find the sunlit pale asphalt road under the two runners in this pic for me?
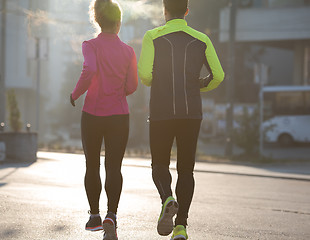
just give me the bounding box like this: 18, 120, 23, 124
0, 152, 310, 240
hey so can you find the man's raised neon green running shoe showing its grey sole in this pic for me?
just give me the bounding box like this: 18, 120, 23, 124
157, 196, 179, 236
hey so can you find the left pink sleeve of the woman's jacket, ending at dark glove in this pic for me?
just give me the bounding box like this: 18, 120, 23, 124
72, 41, 97, 100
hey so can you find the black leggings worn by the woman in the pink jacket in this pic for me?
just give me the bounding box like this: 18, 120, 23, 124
81, 112, 129, 214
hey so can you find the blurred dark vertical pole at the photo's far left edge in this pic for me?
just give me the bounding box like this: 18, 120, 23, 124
0, 0, 6, 123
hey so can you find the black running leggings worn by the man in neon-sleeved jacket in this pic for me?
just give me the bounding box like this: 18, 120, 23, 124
150, 119, 201, 226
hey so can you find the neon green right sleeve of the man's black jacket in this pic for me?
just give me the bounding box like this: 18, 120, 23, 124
200, 37, 225, 92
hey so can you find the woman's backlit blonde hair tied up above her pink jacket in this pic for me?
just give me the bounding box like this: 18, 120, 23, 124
89, 0, 122, 31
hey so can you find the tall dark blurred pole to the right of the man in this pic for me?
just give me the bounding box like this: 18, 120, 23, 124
225, 0, 237, 156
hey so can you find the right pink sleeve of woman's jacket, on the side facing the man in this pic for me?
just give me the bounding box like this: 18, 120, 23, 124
126, 50, 138, 96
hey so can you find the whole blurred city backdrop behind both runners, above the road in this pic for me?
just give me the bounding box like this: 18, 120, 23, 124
0, 0, 310, 161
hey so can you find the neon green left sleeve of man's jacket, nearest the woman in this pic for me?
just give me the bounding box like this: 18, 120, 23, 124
138, 31, 154, 86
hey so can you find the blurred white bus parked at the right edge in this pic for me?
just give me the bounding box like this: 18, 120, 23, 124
261, 86, 310, 146
